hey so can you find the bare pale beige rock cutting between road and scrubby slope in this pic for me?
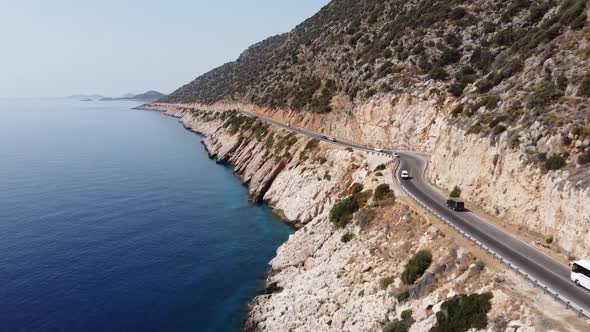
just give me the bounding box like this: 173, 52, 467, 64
146, 98, 590, 259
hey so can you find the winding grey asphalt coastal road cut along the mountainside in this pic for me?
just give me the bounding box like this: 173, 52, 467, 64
242, 112, 590, 316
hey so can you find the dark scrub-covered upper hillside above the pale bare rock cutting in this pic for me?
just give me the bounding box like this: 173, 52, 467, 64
162, 0, 590, 169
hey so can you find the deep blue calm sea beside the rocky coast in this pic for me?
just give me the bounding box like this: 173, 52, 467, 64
0, 99, 291, 331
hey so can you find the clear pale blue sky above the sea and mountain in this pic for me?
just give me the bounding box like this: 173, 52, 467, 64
0, 0, 329, 97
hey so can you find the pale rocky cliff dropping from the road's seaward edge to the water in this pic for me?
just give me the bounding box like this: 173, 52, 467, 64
149, 105, 579, 331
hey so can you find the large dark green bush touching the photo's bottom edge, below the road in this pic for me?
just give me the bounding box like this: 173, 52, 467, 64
430, 292, 493, 332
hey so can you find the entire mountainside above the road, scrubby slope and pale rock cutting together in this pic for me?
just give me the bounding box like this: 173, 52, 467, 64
148, 0, 590, 260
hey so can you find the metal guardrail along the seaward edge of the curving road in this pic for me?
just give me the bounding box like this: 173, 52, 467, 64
395, 176, 590, 323
